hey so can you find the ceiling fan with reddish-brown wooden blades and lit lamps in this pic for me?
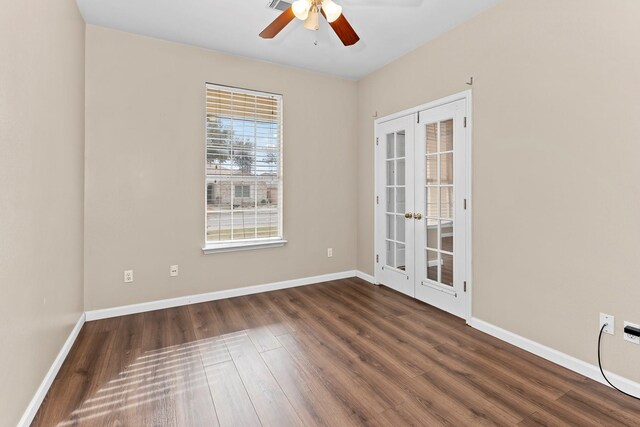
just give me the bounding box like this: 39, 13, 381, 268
260, 0, 360, 46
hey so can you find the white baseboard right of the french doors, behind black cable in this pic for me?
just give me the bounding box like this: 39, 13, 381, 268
468, 317, 640, 396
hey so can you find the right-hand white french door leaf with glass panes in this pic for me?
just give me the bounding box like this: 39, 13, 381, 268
414, 101, 467, 317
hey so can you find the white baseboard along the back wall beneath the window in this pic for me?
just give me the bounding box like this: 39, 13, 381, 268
85, 270, 366, 322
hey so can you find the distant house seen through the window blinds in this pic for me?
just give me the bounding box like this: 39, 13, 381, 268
207, 163, 278, 208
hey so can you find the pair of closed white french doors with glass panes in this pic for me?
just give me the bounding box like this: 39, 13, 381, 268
376, 99, 468, 317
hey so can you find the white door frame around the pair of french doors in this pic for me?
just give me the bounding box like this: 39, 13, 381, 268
373, 89, 473, 324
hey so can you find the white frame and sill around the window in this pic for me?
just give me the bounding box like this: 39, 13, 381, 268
202, 82, 287, 254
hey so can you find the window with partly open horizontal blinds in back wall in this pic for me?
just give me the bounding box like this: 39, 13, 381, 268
204, 84, 285, 253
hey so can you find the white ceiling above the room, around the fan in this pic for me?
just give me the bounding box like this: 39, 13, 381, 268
77, 0, 499, 79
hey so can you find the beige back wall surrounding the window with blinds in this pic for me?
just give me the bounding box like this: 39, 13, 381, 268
85, 26, 357, 310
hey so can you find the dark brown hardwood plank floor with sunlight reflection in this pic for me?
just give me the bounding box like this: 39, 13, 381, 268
33, 279, 640, 427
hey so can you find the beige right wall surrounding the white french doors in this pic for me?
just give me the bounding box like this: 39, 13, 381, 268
358, 0, 640, 381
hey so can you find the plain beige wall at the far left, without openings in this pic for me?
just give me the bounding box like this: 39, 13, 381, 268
0, 0, 85, 426
